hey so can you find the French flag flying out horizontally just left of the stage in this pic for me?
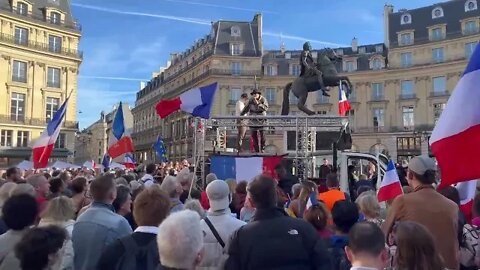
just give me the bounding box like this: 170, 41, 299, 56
156, 83, 217, 119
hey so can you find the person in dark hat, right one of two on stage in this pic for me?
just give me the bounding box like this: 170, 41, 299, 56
240, 89, 268, 153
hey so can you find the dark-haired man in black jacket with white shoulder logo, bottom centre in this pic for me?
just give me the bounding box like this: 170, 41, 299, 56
225, 175, 330, 270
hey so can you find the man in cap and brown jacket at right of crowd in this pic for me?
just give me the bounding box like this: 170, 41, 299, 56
383, 156, 459, 269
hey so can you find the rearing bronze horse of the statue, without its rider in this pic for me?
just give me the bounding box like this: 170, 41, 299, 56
282, 48, 353, 115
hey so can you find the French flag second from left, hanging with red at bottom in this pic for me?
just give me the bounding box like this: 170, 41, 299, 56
107, 102, 135, 158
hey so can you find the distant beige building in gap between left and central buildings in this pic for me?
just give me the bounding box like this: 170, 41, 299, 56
74, 103, 133, 165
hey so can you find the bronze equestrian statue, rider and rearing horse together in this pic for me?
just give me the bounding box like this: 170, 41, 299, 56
282, 42, 353, 115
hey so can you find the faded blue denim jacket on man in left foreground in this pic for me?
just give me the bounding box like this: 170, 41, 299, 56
72, 202, 132, 270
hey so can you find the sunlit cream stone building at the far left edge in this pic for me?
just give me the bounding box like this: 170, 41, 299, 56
0, 0, 82, 167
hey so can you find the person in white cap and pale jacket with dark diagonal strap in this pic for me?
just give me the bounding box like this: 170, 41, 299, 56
197, 180, 246, 269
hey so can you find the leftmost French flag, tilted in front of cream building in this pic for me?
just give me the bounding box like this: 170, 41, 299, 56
32, 98, 68, 169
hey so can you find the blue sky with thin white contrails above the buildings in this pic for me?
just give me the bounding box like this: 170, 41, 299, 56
72, 0, 439, 129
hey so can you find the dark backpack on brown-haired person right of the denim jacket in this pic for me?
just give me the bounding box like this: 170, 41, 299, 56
115, 236, 160, 270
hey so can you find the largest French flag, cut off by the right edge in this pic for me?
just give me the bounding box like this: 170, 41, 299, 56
430, 45, 480, 188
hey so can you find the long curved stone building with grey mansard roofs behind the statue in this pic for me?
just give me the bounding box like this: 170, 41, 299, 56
134, 0, 480, 160
